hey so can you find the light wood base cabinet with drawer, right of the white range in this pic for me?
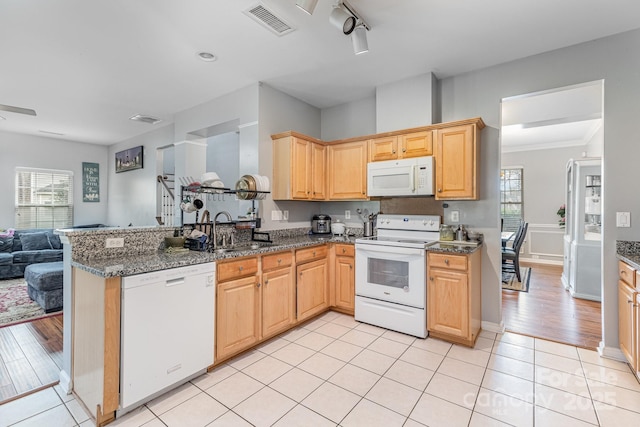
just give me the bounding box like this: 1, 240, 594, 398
427, 250, 482, 347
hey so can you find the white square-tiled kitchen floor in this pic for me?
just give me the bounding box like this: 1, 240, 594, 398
0, 312, 640, 427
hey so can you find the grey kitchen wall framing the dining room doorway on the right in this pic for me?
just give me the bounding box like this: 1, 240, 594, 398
441, 25, 640, 352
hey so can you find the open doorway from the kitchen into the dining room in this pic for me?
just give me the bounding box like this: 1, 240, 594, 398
500, 80, 604, 348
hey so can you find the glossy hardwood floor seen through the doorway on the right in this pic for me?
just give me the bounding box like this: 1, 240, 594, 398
502, 264, 602, 349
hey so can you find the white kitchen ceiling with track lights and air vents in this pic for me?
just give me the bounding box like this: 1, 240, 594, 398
0, 0, 640, 144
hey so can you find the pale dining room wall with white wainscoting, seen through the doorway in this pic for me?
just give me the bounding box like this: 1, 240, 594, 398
502, 146, 585, 264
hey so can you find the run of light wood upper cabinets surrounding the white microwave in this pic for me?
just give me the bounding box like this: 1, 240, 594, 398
271, 117, 485, 200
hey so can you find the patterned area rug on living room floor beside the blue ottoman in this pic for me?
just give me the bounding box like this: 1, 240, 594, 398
0, 278, 60, 328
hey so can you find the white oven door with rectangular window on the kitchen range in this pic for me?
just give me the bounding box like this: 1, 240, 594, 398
356, 244, 427, 308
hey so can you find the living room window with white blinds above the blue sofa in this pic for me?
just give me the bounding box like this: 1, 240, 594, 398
15, 168, 73, 229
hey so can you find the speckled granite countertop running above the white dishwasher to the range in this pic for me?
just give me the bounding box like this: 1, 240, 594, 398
71, 235, 355, 277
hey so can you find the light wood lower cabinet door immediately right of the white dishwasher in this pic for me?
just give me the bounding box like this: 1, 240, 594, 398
216, 276, 260, 359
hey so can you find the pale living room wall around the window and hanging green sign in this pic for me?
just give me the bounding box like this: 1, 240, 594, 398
0, 132, 108, 228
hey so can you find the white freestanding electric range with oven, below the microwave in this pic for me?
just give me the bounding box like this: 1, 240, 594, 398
355, 214, 440, 338
